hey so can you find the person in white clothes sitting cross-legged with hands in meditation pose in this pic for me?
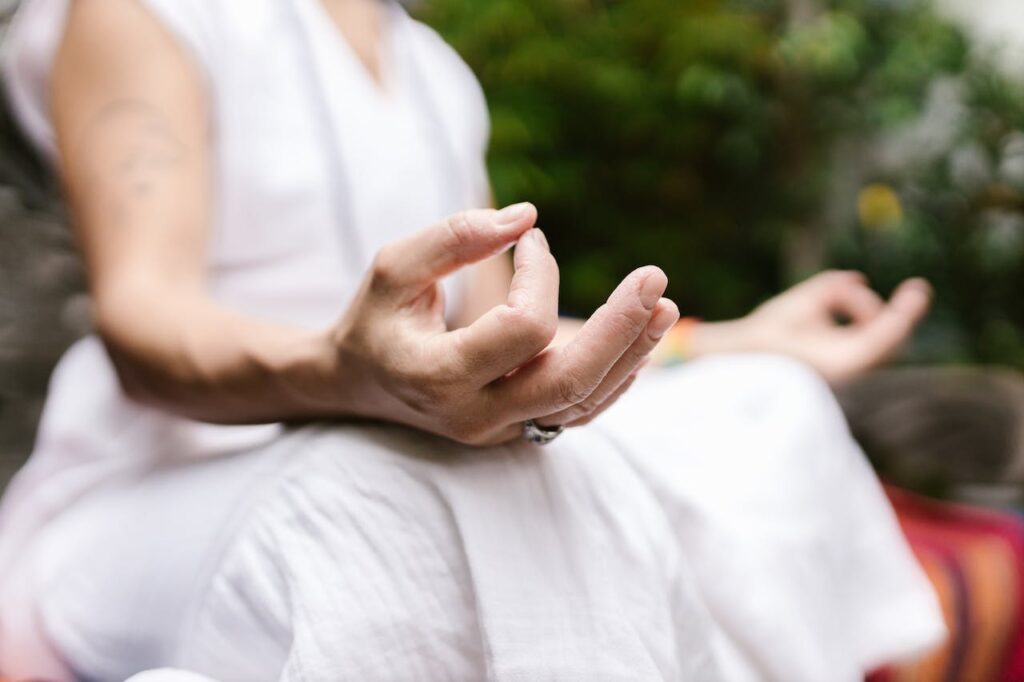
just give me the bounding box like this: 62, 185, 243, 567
0, 0, 943, 682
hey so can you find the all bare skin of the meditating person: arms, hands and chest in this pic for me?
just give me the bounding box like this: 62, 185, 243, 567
52, 0, 928, 445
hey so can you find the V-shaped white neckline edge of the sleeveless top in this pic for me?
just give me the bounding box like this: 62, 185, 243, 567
307, 0, 401, 103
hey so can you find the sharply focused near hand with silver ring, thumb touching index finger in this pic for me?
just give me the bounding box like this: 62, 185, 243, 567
326, 204, 679, 444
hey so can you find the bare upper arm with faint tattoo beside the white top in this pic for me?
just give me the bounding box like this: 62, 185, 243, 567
51, 0, 210, 319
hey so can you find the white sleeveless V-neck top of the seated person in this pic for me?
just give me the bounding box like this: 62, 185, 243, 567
0, 0, 488, 659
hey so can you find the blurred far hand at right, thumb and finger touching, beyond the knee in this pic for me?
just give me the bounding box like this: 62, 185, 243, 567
691, 270, 932, 382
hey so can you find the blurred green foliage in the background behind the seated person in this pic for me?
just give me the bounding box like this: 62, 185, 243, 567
421, 0, 1024, 366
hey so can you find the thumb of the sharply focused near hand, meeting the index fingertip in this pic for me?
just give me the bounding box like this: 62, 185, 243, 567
374, 203, 537, 288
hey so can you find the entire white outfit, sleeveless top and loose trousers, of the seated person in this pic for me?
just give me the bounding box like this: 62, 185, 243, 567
0, 0, 944, 682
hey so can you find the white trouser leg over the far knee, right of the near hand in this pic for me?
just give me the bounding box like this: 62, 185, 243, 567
598, 355, 946, 682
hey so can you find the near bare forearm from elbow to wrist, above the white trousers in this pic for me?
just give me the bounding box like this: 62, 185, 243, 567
96, 288, 339, 423
